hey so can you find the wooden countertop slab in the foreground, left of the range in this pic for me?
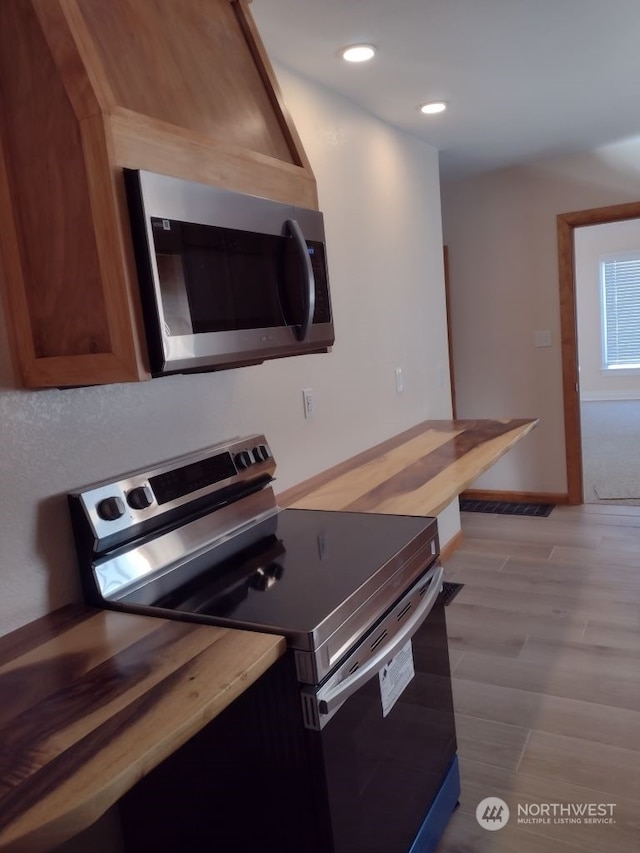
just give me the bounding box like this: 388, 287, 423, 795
0, 607, 285, 853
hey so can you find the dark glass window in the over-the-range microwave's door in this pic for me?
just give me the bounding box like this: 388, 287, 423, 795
152, 217, 310, 335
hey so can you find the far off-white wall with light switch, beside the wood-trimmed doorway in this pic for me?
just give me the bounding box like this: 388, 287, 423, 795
442, 134, 640, 493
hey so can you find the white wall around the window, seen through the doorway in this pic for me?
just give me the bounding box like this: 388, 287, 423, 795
574, 219, 640, 400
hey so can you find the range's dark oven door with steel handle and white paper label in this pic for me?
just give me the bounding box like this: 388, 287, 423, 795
304, 566, 457, 853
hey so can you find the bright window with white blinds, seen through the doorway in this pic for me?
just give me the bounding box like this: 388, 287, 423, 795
600, 251, 640, 369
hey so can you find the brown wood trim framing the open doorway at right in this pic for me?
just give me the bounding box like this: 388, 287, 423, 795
556, 202, 640, 504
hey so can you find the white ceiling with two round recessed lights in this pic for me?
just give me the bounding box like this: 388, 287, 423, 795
251, 0, 640, 180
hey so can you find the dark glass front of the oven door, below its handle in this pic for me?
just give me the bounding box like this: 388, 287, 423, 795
308, 603, 456, 853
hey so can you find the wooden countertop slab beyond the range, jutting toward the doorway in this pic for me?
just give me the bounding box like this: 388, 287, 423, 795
278, 419, 538, 515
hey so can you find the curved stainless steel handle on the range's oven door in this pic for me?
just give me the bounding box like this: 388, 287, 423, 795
318, 565, 444, 715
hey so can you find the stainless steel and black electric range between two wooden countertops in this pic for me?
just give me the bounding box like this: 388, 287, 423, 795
69, 435, 459, 853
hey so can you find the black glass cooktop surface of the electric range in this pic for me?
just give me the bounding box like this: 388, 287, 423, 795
121, 509, 437, 648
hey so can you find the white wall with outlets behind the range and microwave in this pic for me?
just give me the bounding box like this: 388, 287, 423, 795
0, 69, 459, 633
